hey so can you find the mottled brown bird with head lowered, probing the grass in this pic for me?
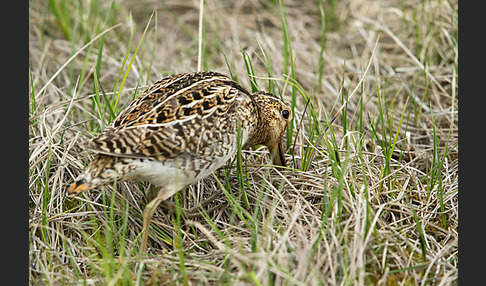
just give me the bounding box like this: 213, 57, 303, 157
67, 71, 292, 252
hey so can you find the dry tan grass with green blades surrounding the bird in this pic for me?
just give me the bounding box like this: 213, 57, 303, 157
29, 0, 458, 285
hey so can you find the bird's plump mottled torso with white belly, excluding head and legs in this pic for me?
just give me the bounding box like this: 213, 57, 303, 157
70, 72, 257, 193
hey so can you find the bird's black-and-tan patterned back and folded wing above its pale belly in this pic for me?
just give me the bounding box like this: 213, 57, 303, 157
83, 72, 248, 159
